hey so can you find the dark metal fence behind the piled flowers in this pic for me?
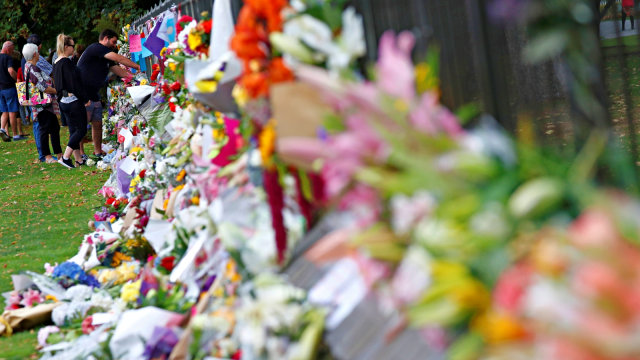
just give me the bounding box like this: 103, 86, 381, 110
129, 0, 640, 188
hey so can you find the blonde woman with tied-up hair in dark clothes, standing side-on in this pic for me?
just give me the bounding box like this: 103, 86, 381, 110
53, 34, 89, 167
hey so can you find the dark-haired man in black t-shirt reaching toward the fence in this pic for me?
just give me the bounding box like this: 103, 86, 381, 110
78, 29, 140, 159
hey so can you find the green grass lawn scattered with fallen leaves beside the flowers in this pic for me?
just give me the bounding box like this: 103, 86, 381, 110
0, 122, 109, 359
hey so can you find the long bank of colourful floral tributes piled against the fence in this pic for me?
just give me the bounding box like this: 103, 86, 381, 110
0, 0, 640, 360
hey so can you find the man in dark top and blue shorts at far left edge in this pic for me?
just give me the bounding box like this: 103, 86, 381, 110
0, 41, 26, 141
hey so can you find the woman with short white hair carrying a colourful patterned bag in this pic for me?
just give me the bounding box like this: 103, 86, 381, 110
22, 44, 61, 166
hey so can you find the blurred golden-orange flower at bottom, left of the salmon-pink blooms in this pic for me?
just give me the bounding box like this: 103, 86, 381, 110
471, 311, 526, 345
